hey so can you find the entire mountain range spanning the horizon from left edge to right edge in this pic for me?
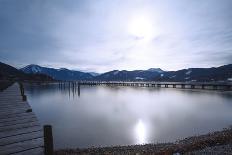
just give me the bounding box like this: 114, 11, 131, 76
0, 63, 232, 82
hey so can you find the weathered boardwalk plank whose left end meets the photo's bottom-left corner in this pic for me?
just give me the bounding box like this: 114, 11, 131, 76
0, 138, 43, 155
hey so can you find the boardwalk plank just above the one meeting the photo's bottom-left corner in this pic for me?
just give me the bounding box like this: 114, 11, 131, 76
0, 131, 43, 146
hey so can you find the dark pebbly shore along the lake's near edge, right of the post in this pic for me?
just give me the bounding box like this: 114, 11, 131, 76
55, 128, 232, 155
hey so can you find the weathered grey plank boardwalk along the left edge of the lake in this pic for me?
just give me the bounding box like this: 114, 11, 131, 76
0, 83, 52, 155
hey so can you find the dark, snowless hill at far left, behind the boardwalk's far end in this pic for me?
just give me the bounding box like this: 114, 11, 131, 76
0, 62, 53, 81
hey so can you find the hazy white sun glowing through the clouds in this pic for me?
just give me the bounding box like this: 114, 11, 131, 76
128, 16, 153, 39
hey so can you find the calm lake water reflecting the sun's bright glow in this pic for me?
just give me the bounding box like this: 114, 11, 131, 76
25, 84, 232, 148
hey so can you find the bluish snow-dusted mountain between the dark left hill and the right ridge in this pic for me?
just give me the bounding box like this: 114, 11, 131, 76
20, 64, 94, 80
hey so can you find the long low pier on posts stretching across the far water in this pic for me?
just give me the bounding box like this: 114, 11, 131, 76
60, 81, 232, 90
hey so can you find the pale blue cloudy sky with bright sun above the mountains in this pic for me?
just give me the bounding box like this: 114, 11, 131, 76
0, 0, 232, 73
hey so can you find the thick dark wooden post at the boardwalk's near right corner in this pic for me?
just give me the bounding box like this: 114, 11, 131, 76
44, 125, 54, 155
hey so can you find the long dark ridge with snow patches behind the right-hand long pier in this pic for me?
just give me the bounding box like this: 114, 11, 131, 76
95, 64, 232, 82
